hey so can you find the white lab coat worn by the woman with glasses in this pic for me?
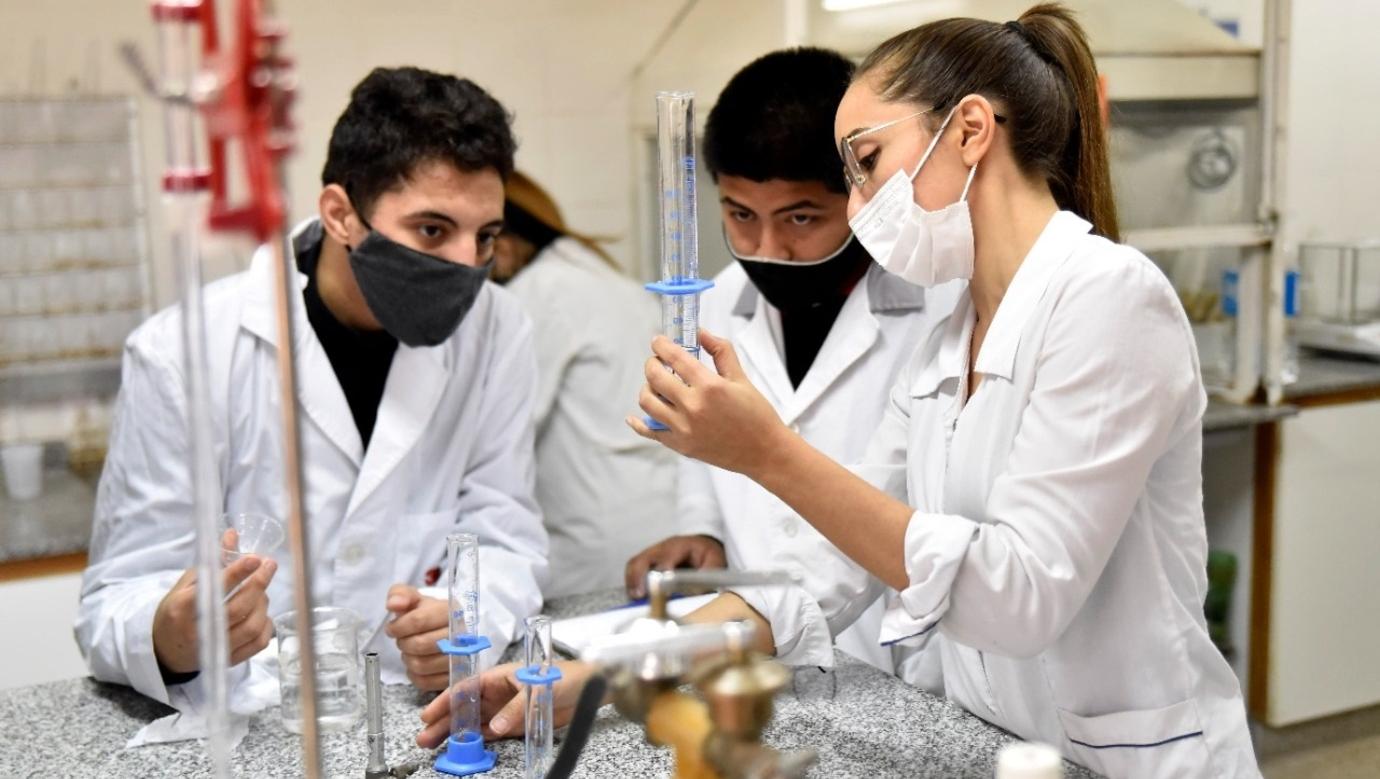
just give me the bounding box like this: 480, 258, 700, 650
860, 211, 1259, 779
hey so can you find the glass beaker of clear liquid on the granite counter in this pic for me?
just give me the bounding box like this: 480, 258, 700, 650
273, 606, 364, 733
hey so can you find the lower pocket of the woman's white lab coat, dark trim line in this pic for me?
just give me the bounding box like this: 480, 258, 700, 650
1057, 698, 1210, 778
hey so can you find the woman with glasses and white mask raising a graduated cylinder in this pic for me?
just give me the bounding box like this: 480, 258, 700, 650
628, 6, 1259, 778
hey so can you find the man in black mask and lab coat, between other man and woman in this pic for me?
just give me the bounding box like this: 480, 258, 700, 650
627, 48, 956, 678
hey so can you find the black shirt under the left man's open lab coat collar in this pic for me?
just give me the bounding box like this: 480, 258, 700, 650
294, 228, 397, 449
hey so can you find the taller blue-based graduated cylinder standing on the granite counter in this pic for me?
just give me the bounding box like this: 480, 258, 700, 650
436, 533, 495, 776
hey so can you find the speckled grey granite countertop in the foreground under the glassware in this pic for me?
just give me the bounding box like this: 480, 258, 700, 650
0, 593, 1093, 779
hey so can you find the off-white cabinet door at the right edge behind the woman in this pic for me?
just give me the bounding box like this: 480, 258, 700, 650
1261, 401, 1380, 727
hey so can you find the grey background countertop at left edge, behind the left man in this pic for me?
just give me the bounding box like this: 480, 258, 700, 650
0, 468, 95, 564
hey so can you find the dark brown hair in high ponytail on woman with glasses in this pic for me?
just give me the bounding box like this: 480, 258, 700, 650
854, 3, 1121, 240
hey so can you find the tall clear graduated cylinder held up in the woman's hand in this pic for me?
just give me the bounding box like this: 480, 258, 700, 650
646, 91, 713, 430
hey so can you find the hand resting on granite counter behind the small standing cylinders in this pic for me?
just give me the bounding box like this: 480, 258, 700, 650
417, 660, 593, 749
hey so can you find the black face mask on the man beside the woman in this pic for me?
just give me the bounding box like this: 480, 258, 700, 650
725, 233, 872, 312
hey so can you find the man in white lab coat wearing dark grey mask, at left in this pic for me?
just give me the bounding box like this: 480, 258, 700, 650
76, 68, 546, 707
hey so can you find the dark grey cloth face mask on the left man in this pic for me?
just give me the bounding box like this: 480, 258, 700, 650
346, 225, 491, 347
